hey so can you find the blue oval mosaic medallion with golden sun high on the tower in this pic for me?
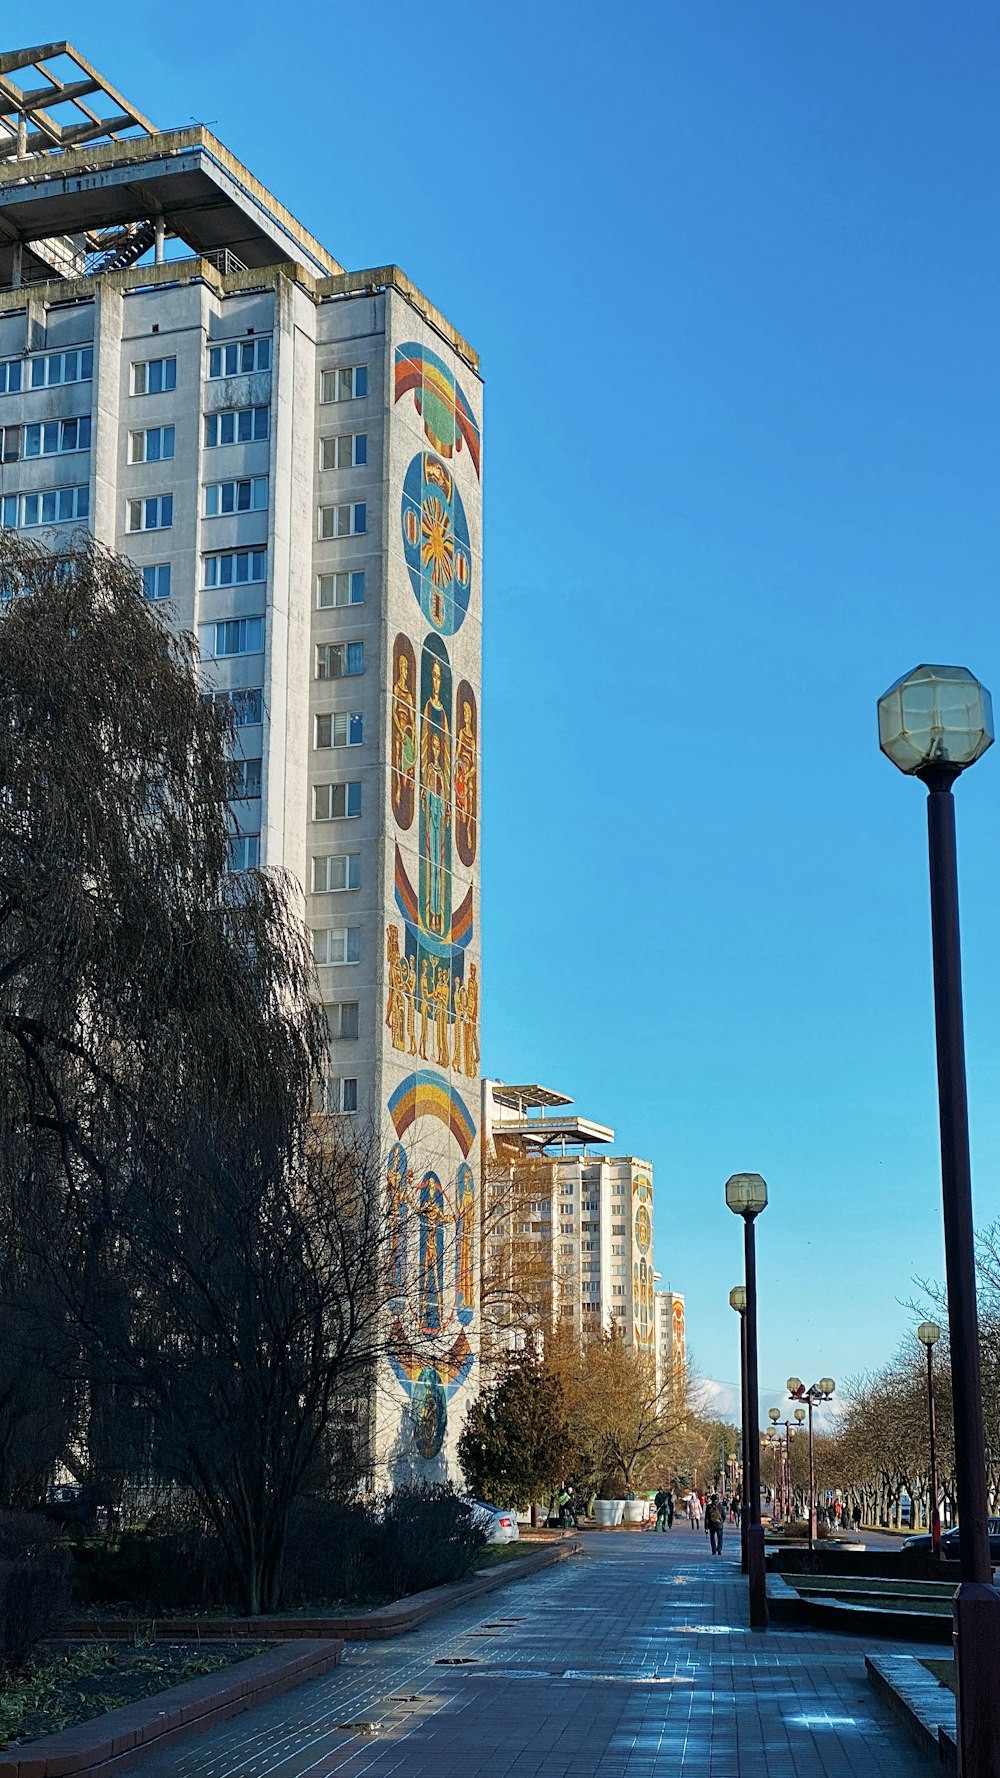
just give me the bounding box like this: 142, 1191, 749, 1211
400, 452, 472, 637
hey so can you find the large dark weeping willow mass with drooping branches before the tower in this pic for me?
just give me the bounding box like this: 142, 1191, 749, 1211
0, 532, 383, 1611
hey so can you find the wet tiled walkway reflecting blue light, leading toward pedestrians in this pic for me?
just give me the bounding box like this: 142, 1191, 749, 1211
124, 1527, 940, 1778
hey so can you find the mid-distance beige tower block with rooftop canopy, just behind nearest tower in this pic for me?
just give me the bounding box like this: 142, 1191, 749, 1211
482, 1081, 655, 1357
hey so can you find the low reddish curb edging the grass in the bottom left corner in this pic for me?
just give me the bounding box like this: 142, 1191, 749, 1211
0, 1639, 343, 1778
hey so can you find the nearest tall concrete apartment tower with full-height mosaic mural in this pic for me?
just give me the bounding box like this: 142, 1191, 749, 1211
0, 43, 482, 1479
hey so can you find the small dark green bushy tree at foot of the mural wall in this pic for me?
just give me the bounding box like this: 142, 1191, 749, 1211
459, 1353, 575, 1508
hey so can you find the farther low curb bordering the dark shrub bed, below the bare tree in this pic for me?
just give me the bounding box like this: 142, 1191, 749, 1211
64, 1542, 582, 1649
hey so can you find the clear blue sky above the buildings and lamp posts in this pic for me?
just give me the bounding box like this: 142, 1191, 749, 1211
17, 0, 1000, 1405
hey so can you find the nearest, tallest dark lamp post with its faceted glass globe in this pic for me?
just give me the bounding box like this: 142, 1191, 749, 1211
879, 667, 1000, 1778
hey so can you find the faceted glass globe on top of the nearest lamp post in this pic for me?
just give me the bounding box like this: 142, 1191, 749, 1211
879, 667, 993, 773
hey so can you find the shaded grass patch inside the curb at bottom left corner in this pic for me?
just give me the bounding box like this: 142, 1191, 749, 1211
0, 1641, 267, 1748
